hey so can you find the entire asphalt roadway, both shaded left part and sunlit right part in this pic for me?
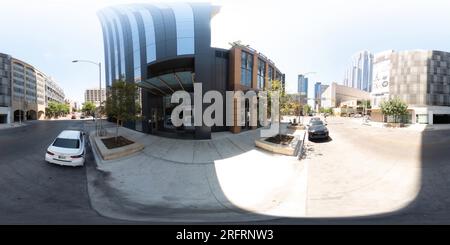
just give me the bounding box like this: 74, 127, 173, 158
0, 118, 450, 224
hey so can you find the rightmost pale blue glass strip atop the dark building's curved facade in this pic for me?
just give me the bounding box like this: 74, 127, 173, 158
170, 3, 195, 55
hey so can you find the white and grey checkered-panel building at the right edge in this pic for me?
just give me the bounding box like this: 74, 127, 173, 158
371, 50, 450, 124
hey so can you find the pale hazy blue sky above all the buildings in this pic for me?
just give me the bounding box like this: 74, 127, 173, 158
0, 0, 450, 103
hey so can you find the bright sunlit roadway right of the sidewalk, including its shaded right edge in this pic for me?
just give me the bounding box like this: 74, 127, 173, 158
279, 118, 450, 224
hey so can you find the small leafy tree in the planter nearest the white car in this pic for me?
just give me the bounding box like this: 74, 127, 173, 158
105, 80, 141, 141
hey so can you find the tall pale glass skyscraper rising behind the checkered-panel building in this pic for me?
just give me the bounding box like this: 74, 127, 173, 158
344, 51, 373, 92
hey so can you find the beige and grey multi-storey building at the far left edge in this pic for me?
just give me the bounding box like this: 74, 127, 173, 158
0, 54, 64, 123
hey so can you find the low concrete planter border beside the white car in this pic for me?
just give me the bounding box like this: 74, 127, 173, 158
91, 136, 144, 160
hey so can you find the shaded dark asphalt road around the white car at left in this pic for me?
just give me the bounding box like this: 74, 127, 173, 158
0, 120, 128, 224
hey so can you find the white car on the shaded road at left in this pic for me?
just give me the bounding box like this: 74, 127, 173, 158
45, 130, 85, 167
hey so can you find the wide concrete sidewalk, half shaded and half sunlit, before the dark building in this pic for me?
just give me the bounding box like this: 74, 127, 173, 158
88, 122, 306, 222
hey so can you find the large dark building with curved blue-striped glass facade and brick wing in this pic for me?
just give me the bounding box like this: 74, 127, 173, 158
98, 3, 285, 139
